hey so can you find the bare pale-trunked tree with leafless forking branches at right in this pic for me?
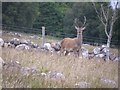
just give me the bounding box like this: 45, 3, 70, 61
93, 2, 118, 60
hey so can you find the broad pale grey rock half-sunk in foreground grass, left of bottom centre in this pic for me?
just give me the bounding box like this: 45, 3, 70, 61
45, 71, 65, 81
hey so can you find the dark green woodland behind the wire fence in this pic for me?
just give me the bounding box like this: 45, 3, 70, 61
2, 2, 120, 43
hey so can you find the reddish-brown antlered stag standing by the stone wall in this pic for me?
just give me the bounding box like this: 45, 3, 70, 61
61, 16, 86, 56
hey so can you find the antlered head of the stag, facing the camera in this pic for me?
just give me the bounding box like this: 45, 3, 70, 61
74, 16, 86, 35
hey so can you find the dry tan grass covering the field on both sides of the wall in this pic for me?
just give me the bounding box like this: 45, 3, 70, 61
2, 31, 118, 88
